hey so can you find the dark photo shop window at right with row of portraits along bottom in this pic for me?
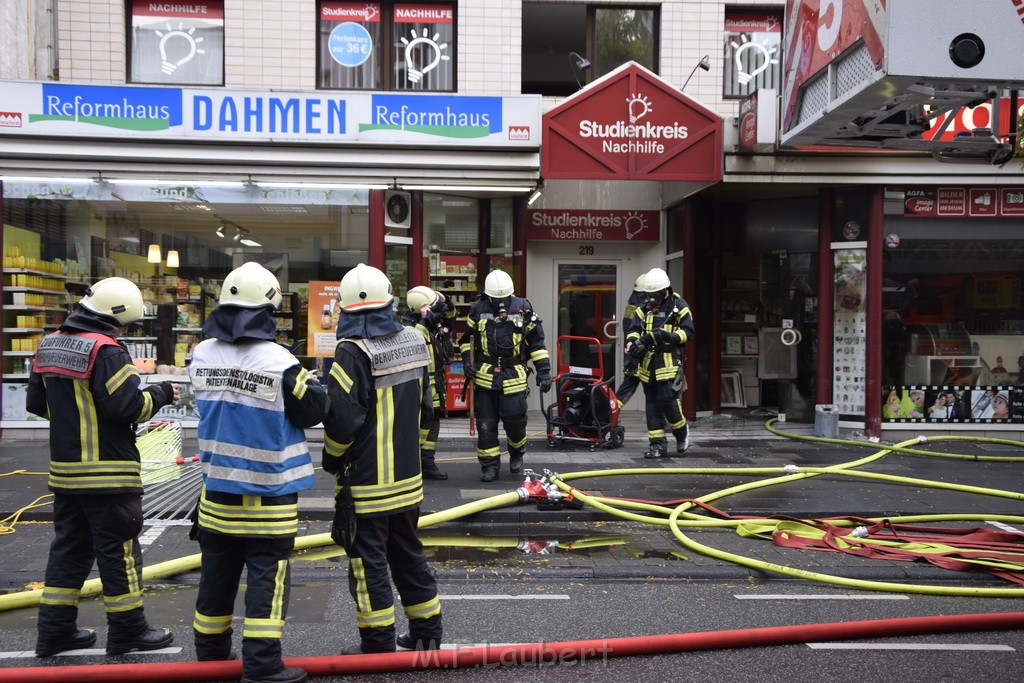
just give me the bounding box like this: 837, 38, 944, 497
882, 197, 1024, 422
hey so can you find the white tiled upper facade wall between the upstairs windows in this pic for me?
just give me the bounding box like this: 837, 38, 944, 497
41, 0, 785, 115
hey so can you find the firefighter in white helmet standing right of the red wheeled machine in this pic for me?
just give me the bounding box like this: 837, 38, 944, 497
627, 268, 693, 458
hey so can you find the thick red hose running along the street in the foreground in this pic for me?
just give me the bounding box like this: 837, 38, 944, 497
0, 612, 1024, 683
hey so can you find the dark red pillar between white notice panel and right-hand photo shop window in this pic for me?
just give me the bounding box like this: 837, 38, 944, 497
864, 185, 885, 436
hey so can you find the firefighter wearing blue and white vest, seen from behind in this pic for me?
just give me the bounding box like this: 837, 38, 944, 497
188, 262, 328, 683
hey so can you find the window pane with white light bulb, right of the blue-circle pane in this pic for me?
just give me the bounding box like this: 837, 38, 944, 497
391, 2, 455, 90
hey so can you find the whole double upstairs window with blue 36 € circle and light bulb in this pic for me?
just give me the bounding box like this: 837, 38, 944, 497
317, 0, 456, 92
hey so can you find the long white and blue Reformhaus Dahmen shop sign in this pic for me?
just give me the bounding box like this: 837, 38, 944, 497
0, 81, 541, 148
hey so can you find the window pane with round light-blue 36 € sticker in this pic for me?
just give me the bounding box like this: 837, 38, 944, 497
319, 2, 383, 90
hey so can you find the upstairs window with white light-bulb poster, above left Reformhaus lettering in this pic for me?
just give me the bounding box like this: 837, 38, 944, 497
127, 0, 224, 86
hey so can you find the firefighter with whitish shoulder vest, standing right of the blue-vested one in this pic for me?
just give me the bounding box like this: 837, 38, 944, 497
324, 263, 441, 654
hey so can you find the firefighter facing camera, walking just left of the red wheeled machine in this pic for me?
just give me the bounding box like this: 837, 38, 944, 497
459, 270, 551, 481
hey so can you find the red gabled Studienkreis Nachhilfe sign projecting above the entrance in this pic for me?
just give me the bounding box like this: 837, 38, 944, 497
541, 61, 722, 182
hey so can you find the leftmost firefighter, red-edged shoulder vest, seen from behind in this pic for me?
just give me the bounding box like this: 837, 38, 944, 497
26, 278, 178, 656
